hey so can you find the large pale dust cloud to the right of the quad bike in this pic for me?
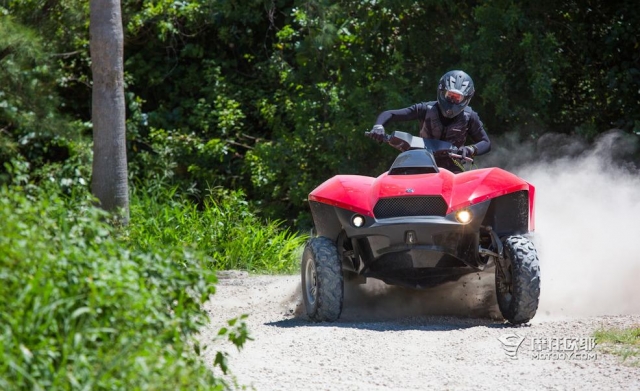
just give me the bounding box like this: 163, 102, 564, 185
509, 131, 640, 318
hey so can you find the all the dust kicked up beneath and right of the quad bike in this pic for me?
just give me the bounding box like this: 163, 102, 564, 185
300, 131, 640, 321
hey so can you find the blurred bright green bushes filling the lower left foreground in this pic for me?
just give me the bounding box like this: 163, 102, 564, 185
0, 173, 248, 390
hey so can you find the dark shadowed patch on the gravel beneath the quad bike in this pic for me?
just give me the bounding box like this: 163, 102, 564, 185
267, 269, 513, 331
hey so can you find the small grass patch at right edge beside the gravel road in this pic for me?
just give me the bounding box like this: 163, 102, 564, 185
594, 326, 640, 366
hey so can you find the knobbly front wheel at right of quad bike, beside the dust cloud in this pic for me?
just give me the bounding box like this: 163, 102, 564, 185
496, 236, 540, 324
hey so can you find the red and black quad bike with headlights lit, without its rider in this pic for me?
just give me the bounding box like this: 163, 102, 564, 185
301, 132, 540, 324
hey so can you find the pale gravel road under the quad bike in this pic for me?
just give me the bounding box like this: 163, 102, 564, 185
199, 272, 640, 391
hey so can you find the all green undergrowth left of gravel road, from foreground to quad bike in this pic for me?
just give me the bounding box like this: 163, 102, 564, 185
0, 161, 306, 390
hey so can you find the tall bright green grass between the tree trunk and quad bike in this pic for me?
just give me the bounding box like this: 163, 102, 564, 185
128, 186, 305, 273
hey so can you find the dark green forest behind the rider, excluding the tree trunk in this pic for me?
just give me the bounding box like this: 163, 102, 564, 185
0, 0, 640, 231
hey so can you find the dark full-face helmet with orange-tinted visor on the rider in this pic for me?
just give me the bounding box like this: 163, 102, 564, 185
438, 71, 475, 118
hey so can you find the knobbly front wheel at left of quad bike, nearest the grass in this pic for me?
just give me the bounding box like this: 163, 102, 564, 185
300, 236, 344, 322
